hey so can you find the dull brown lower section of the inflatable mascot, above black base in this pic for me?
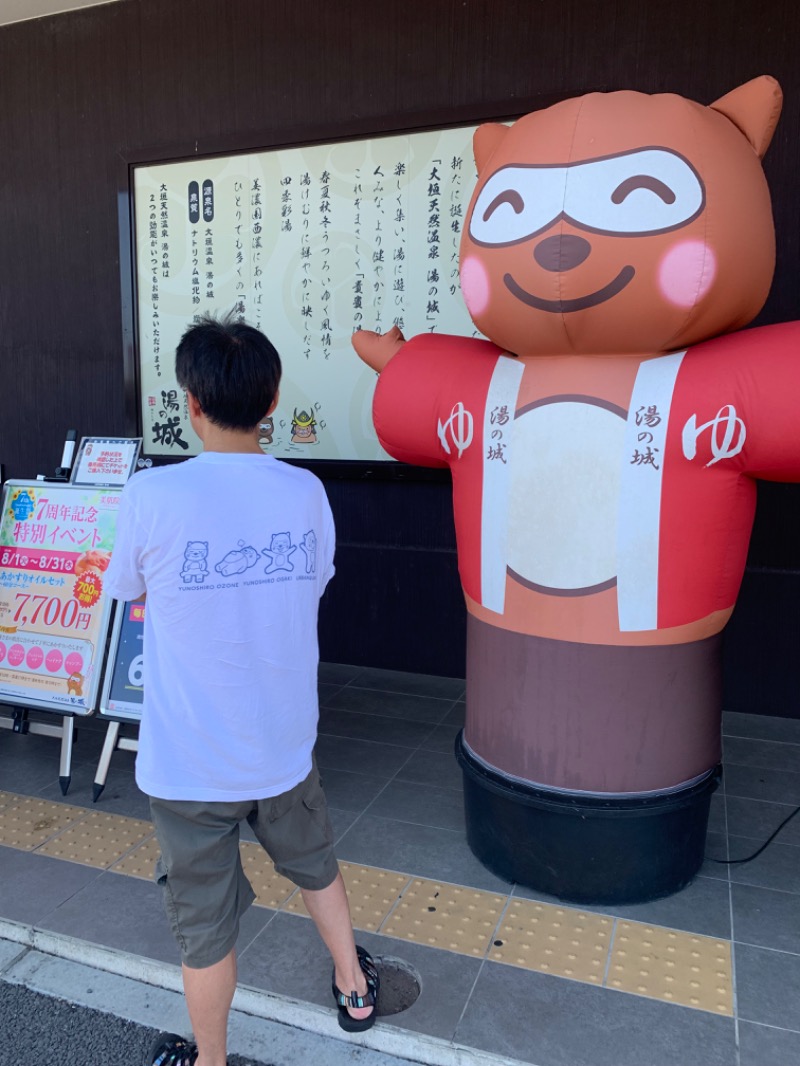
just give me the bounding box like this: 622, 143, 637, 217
464, 616, 722, 793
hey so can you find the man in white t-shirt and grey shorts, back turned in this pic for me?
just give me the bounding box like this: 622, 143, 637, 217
107, 318, 379, 1066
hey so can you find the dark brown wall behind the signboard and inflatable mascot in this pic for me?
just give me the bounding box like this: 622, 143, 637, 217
0, 0, 800, 713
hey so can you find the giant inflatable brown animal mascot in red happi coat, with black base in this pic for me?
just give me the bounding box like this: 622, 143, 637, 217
353, 77, 800, 903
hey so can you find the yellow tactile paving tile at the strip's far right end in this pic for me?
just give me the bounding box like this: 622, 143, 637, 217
607, 919, 733, 1015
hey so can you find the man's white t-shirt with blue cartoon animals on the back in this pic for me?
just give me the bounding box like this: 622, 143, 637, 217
106, 452, 335, 802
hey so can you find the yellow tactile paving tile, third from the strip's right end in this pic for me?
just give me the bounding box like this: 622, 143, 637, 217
381, 878, 508, 956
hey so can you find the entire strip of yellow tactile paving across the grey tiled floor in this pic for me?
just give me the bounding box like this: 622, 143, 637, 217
0, 791, 733, 1017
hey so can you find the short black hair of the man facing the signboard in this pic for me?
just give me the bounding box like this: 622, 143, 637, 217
175, 313, 281, 430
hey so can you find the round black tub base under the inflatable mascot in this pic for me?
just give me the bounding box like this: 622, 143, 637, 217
455, 733, 722, 904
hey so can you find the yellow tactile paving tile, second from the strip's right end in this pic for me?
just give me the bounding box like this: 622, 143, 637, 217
489, 900, 613, 985
